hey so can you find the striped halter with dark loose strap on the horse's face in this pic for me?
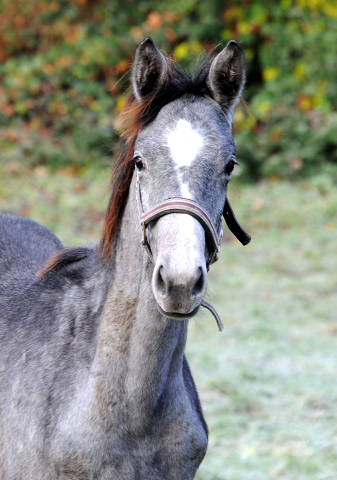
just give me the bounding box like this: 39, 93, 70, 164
135, 167, 251, 331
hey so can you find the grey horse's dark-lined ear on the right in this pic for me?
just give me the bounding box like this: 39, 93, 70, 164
207, 40, 245, 121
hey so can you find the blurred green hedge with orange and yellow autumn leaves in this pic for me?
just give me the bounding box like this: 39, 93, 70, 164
0, 0, 337, 178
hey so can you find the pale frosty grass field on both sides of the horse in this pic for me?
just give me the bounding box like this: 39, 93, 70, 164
0, 164, 337, 480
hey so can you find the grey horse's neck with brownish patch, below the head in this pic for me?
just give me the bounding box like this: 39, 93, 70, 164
93, 174, 188, 421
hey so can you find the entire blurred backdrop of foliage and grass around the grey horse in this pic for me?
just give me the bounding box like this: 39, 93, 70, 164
0, 0, 337, 480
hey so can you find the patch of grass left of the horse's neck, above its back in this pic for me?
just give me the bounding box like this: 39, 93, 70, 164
0, 164, 109, 246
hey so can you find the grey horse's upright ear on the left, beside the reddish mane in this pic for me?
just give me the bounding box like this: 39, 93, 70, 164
132, 38, 167, 100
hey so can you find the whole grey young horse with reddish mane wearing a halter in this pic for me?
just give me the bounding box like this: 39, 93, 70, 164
0, 38, 250, 480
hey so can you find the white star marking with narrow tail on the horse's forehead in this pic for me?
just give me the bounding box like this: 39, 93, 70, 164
167, 120, 204, 198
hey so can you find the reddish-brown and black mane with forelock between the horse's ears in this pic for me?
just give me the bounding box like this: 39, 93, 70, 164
99, 59, 211, 260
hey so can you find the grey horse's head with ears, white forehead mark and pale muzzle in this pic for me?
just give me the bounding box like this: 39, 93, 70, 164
132, 38, 245, 319
